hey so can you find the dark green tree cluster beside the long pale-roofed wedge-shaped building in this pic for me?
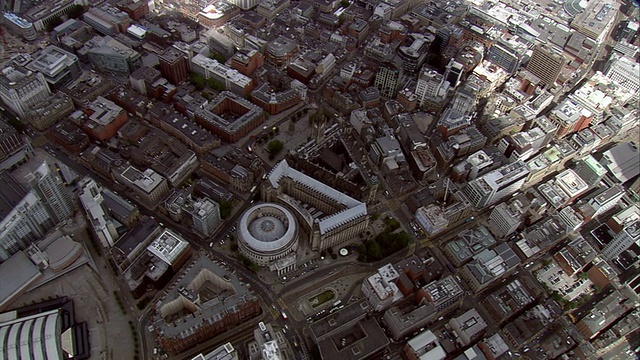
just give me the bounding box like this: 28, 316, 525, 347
358, 218, 411, 262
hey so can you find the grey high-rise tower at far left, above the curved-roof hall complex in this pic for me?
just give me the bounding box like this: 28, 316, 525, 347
27, 162, 75, 222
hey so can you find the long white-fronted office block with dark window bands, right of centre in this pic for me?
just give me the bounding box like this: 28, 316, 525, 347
463, 160, 529, 208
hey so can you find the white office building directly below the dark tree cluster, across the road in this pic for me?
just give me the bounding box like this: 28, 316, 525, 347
362, 264, 403, 311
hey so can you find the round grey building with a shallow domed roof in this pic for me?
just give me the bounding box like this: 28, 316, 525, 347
238, 203, 298, 266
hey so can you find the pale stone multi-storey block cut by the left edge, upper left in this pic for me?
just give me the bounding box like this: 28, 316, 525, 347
0, 66, 51, 118
